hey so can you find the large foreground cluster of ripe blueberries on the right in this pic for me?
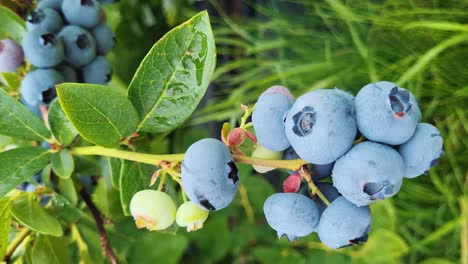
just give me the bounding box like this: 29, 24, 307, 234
252, 81, 443, 249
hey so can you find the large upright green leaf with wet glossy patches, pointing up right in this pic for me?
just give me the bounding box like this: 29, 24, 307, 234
128, 11, 216, 133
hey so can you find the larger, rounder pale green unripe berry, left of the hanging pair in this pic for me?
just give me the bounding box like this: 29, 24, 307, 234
130, 190, 176, 231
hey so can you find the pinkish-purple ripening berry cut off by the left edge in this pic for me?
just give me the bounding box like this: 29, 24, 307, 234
0, 39, 24, 72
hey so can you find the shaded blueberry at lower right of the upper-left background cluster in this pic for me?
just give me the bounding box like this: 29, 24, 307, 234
81, 56, 112, 84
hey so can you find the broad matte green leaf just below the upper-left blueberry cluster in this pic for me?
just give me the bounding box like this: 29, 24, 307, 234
57, 83, 138, 147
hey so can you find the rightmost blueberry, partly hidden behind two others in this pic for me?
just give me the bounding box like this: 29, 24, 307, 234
398, 123, 443, 178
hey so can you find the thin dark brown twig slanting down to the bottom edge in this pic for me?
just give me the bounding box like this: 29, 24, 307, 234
80, 188, 118, 264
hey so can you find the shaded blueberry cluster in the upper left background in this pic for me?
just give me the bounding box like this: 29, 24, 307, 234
21, 0, 115, 113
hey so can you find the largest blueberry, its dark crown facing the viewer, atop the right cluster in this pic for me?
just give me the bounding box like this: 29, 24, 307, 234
285, 89, 357, 165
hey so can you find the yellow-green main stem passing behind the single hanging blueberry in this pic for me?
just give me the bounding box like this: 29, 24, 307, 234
71, 146, 307, 170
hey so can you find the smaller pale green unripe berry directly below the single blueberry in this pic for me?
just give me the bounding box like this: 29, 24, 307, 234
176, 201, 208, 232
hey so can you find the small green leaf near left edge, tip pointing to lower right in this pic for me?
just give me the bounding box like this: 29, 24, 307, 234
11, 193, 63, 237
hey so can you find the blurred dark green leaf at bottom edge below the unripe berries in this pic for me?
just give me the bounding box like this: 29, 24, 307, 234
128, 232, 188, 264
